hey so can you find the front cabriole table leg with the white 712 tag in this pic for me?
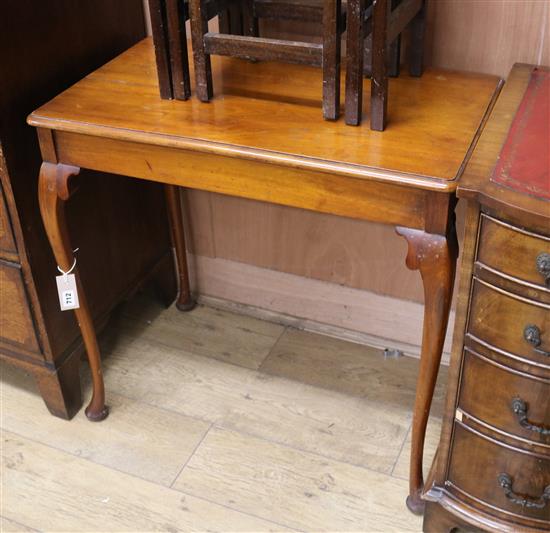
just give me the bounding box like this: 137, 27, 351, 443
38, 163, 109, 421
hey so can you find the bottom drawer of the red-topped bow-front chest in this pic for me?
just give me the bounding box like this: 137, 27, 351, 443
447, 423, 550, 527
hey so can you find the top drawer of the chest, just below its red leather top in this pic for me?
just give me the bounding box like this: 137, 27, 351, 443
477, 215, 550, 289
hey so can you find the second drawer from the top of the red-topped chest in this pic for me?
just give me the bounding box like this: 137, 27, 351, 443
468, 278, 550, 368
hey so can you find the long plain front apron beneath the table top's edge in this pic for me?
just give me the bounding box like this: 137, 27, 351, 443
53, 131, 453, 233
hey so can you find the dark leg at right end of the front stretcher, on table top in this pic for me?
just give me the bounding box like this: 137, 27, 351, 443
323, 0, 342, 120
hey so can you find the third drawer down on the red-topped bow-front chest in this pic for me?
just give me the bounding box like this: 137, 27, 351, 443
458, 349, 550, 444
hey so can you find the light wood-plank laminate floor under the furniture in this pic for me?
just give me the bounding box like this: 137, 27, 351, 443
0, 296, 446, 533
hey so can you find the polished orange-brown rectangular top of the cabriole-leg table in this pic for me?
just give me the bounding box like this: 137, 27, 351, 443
29, 38, 499, 190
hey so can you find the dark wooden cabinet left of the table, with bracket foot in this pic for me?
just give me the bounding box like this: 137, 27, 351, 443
0, 0, 176, 418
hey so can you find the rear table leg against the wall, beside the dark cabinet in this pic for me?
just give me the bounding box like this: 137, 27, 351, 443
164, 185, 196, 311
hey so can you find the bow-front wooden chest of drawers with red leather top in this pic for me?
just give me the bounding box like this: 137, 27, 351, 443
423, 61, 550, 533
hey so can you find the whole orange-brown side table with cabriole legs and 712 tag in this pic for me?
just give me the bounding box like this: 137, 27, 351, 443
29, 39, 500, 512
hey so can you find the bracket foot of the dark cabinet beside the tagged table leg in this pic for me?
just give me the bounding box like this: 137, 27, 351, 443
35, 352, 82, 420
